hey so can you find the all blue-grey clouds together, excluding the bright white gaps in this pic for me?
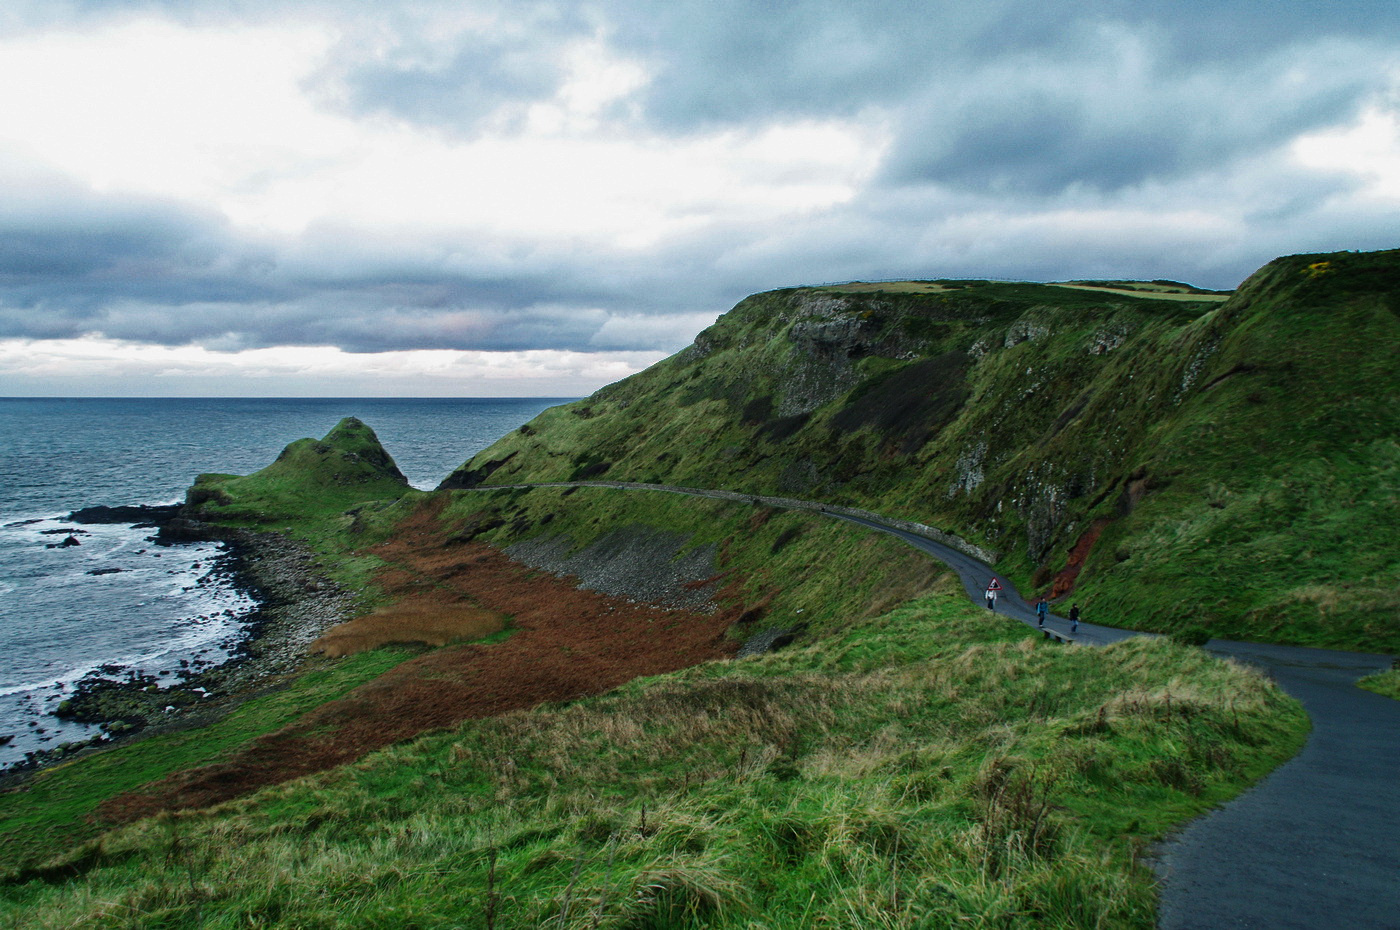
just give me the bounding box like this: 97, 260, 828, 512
0, 0, 1400, 366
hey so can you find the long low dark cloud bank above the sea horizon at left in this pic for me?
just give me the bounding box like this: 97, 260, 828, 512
0, 178, 688, 352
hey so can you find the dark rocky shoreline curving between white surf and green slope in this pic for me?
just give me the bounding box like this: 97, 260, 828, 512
0, 515, 357, 790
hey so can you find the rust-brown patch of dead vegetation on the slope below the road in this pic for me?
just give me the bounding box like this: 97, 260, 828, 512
98, 504, 735, 822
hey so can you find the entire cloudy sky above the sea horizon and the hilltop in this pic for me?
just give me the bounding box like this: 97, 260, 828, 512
0, 0, 1400, 396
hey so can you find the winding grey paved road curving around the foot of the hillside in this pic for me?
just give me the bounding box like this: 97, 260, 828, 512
476, 482, 1400, 930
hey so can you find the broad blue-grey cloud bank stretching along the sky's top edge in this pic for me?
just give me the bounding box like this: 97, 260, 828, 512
10, 0, 1400, 192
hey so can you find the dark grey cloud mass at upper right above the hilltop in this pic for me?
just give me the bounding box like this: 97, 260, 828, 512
885, 36, 1383, 195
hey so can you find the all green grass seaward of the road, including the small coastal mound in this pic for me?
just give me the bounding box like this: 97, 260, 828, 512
0, 369, 1306, 930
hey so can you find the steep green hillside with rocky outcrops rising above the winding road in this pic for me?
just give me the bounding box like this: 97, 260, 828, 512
442, 252, 1400, 647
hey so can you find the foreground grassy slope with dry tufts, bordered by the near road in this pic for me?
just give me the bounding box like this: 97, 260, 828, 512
0, 583, 1306, 929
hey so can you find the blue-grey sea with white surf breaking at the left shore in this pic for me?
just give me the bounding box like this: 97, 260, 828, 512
0, 398, 573, 769
